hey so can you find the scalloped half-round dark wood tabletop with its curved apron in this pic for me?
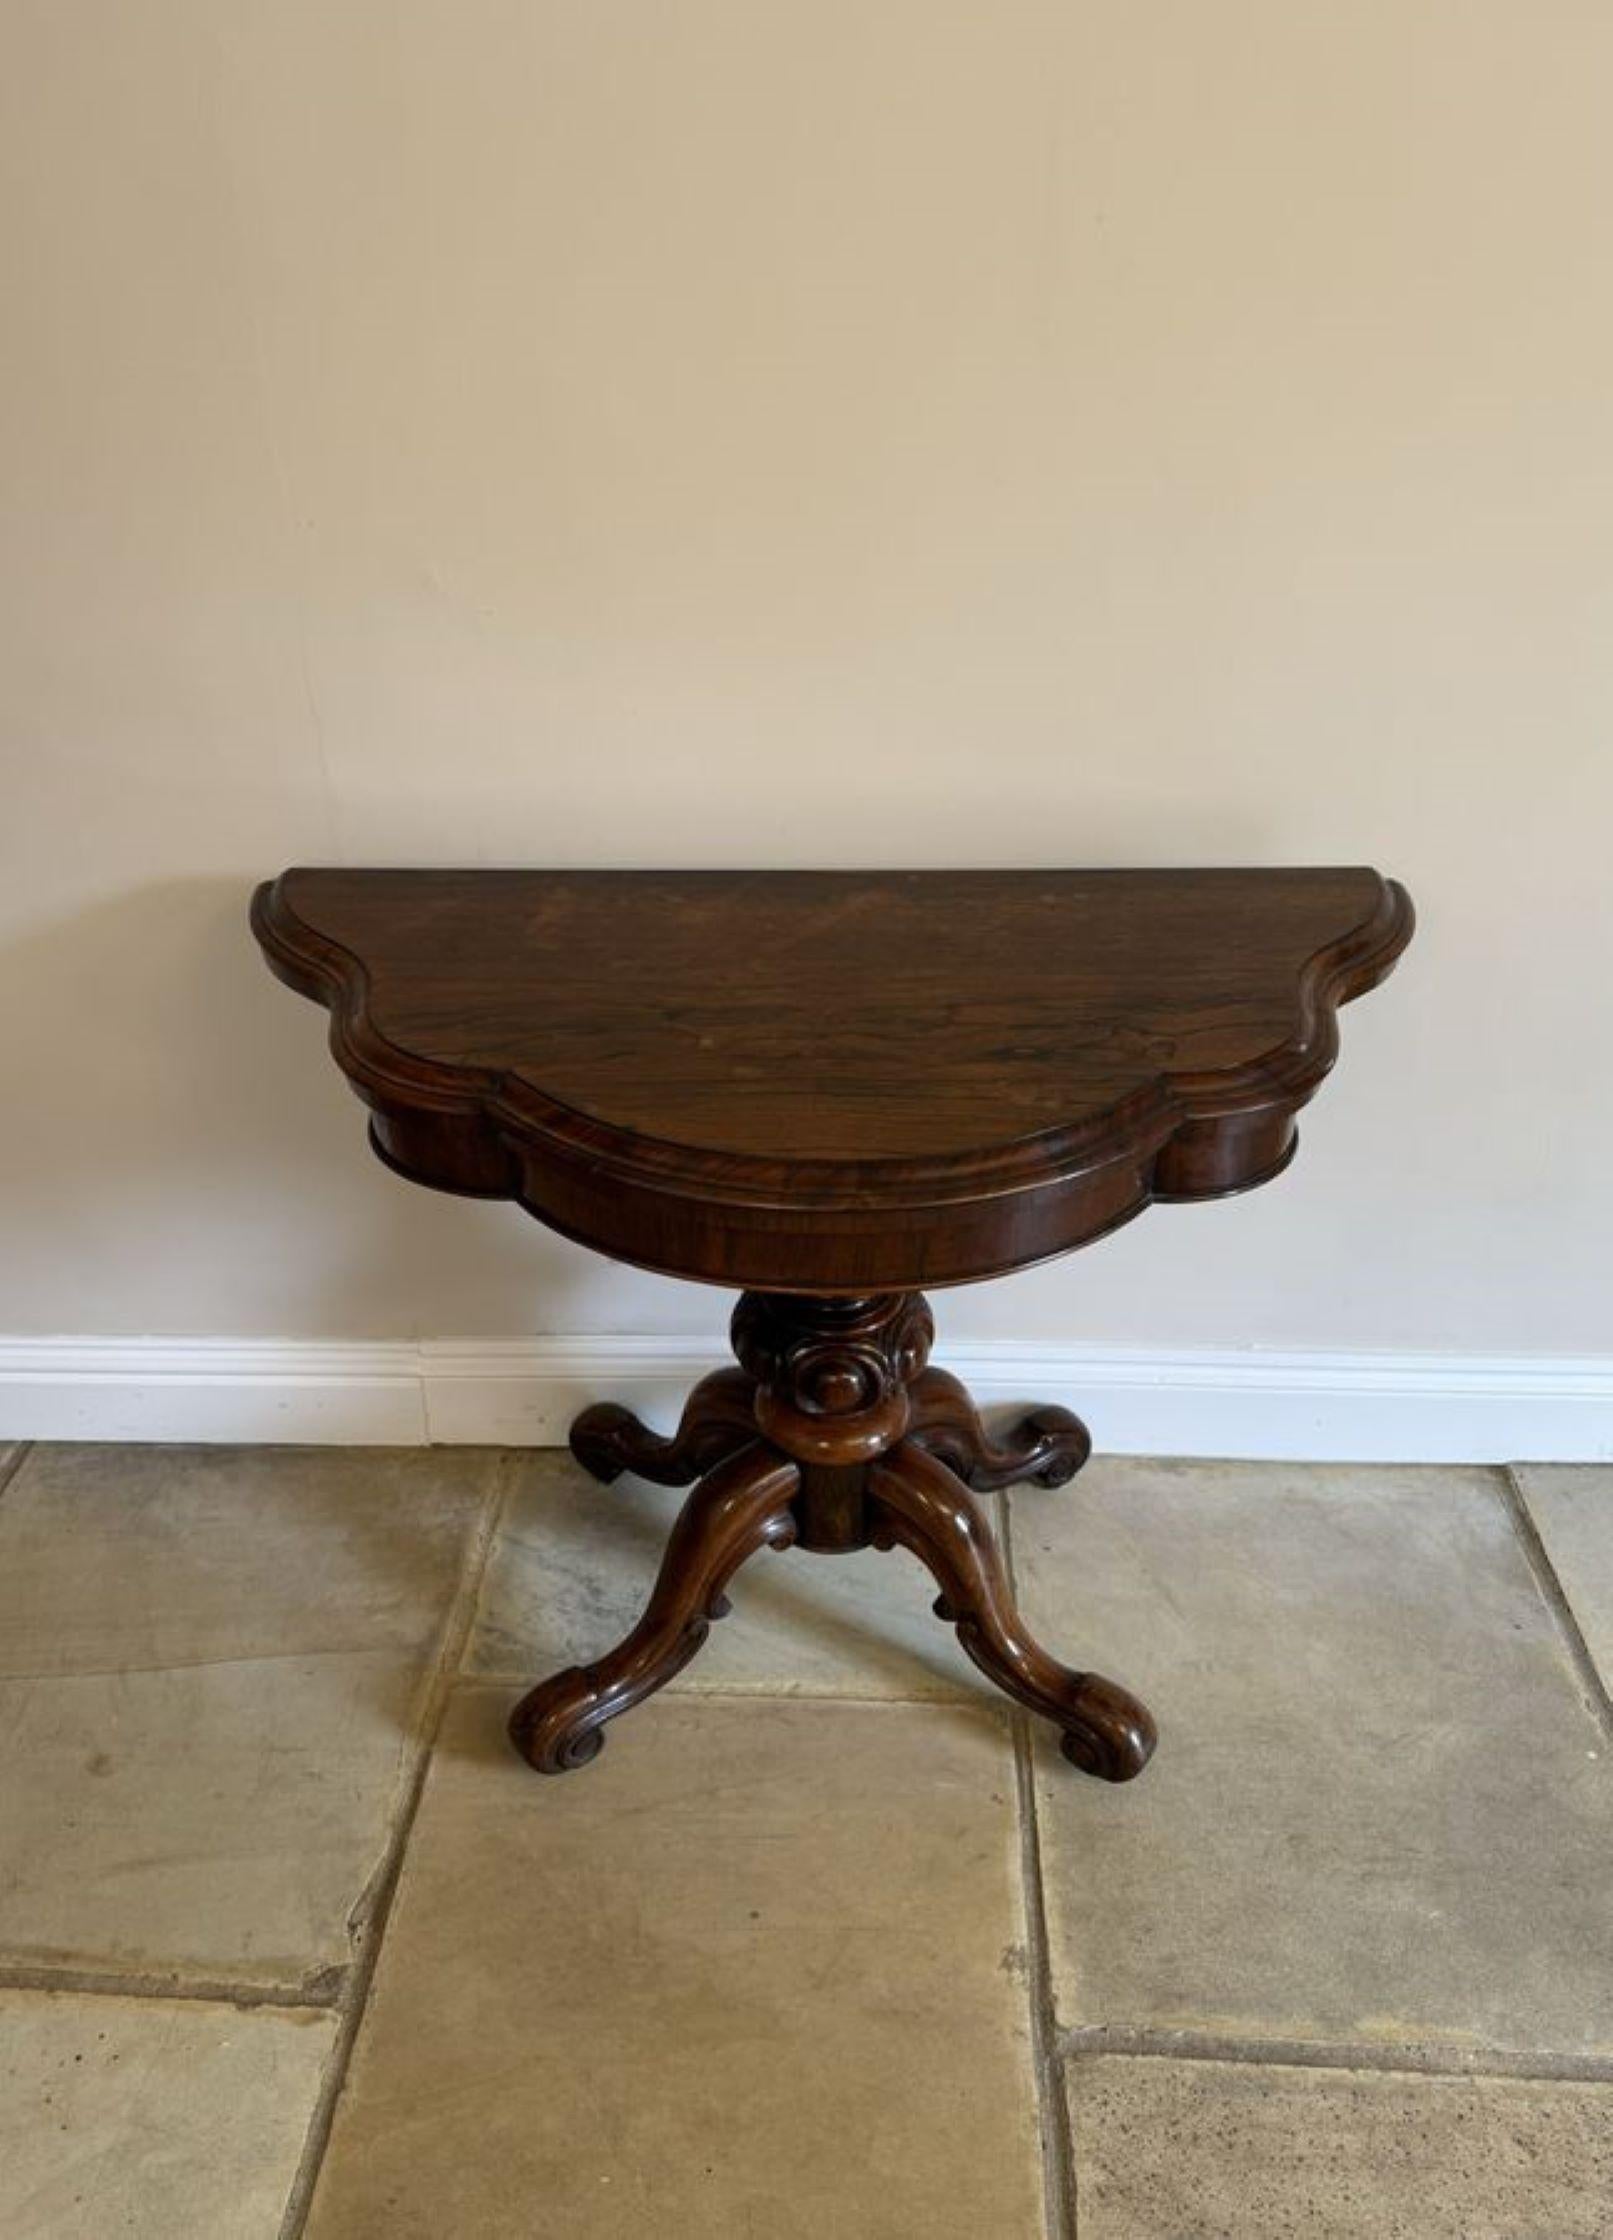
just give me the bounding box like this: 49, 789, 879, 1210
253, 871, 1411, 1295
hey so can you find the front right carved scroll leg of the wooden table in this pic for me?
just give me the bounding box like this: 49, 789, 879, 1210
869, 1440, 1158, 1781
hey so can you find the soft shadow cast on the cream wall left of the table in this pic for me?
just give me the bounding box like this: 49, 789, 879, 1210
0, 878, 607, 1337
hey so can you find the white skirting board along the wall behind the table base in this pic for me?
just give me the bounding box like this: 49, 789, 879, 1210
0, 1337, 1613, 1463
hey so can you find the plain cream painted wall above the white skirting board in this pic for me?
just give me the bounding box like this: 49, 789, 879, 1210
0, 0, 1613, 1353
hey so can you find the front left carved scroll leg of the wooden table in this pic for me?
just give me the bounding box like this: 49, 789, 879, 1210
509, 1445, 800, 1774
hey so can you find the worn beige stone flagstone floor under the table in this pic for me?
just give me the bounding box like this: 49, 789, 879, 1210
0, 1447, 1613, 2240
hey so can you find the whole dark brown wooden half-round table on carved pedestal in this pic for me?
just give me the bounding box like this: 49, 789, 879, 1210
253, 869, 1411, 1781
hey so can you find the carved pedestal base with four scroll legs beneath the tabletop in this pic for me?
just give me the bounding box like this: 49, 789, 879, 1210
511, 1292, 1156, 1781
